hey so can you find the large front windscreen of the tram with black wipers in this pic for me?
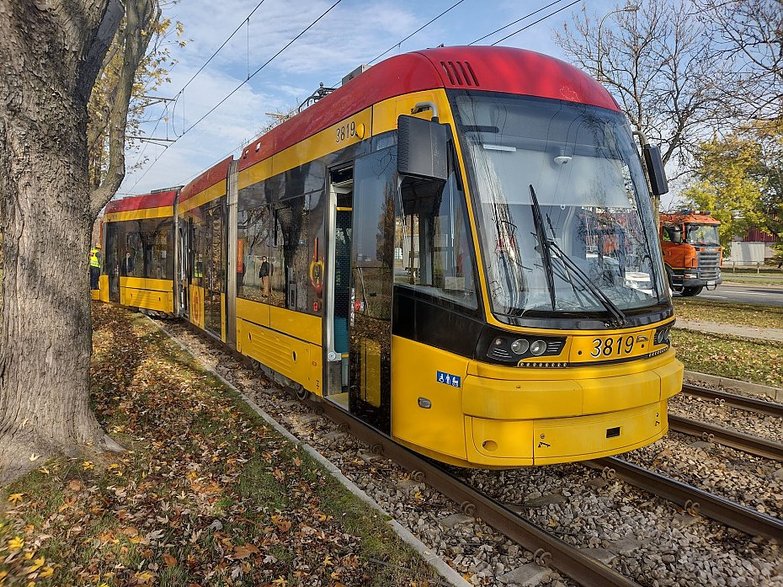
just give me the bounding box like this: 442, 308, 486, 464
454, 93, 669, 317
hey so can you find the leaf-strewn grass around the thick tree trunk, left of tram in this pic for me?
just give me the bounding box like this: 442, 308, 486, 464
0, 304, 439, 587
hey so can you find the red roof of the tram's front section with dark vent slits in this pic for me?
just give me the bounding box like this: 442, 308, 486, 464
239, 47, 619, 172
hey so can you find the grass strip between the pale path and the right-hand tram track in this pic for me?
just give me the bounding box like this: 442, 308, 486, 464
672, 329, 783, 387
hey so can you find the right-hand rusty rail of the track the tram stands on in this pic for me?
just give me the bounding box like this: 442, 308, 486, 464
596, 457, 783, 543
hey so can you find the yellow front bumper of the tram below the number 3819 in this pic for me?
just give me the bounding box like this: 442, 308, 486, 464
462, 351, 683, 467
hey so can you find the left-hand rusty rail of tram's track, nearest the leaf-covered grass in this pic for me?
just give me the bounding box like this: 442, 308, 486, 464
309, 399, 638, 587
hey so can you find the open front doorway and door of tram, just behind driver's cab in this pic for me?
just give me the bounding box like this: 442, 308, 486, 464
326, 152, 397, 433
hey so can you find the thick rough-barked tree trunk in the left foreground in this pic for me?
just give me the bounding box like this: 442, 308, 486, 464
0, 0, 121, 482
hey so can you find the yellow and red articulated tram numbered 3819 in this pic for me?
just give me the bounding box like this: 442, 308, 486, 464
101, 47, 682, 467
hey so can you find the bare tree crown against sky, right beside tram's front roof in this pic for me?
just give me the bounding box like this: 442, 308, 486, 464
556, 0, 719, 170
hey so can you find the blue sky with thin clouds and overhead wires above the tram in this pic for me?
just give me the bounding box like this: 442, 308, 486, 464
119, 0, 616, 196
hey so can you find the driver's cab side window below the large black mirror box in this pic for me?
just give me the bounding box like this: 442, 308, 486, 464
394, 171, 478, 309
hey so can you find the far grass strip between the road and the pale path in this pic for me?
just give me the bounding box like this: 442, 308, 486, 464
672, 296, 783, 328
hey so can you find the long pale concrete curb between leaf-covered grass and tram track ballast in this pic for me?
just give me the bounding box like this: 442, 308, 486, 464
147, 314, 472, 587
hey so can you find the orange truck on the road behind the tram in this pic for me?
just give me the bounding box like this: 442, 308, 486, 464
660, 210, 723, 296
